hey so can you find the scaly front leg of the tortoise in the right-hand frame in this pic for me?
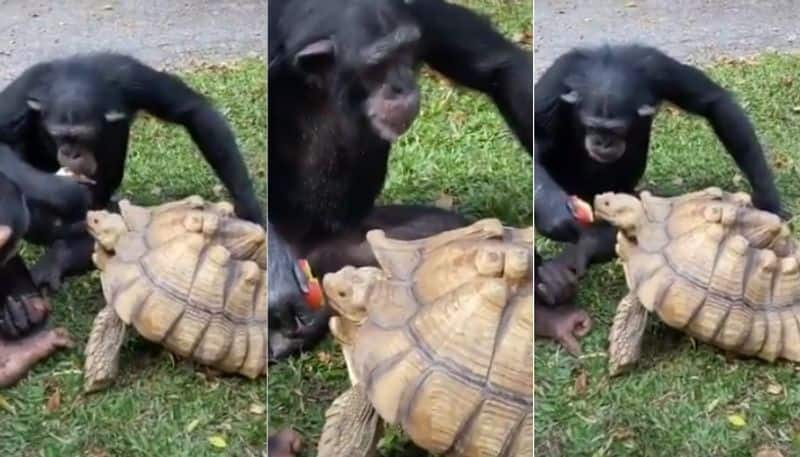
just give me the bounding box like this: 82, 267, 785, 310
608, 292, 647, 376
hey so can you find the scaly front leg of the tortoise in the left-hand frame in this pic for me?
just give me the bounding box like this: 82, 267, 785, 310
83, 305, 125, 393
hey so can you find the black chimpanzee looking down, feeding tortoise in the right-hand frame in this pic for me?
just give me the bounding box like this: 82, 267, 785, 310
534, 45, 783, 352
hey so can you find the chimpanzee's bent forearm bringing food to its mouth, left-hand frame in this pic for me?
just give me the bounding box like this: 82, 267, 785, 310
0, 145, 91, 221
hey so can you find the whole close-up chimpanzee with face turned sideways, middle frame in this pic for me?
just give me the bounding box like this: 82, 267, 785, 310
268, 0, 533, 358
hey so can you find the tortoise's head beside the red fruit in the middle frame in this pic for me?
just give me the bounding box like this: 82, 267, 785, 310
322, 266, 384, 324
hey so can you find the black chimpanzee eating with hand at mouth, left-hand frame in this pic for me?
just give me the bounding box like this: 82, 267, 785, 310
0, 53, 265, 290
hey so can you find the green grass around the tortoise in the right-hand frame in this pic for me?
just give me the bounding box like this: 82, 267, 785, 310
535, 51, 800, 456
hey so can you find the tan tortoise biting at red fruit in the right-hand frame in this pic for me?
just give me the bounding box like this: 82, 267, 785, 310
594, 187, 800, 375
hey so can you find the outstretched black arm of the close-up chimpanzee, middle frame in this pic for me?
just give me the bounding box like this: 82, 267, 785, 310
398, 0, 533, 152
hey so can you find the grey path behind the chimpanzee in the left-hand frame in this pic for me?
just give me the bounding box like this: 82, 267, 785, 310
0, 0, 267, 84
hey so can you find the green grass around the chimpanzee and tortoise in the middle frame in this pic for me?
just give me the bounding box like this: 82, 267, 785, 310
268, 0, 533, 456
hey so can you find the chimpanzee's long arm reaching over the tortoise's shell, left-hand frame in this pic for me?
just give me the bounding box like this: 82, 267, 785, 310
99, 55, 266, 225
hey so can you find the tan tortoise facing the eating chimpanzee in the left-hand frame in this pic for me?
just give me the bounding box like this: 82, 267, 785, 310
84, 196, 267, 392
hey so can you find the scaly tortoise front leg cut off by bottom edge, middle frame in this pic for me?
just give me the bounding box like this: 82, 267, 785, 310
317, 386, 383, 457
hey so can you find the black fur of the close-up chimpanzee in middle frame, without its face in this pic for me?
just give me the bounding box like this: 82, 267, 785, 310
268, 0, 533, 358
